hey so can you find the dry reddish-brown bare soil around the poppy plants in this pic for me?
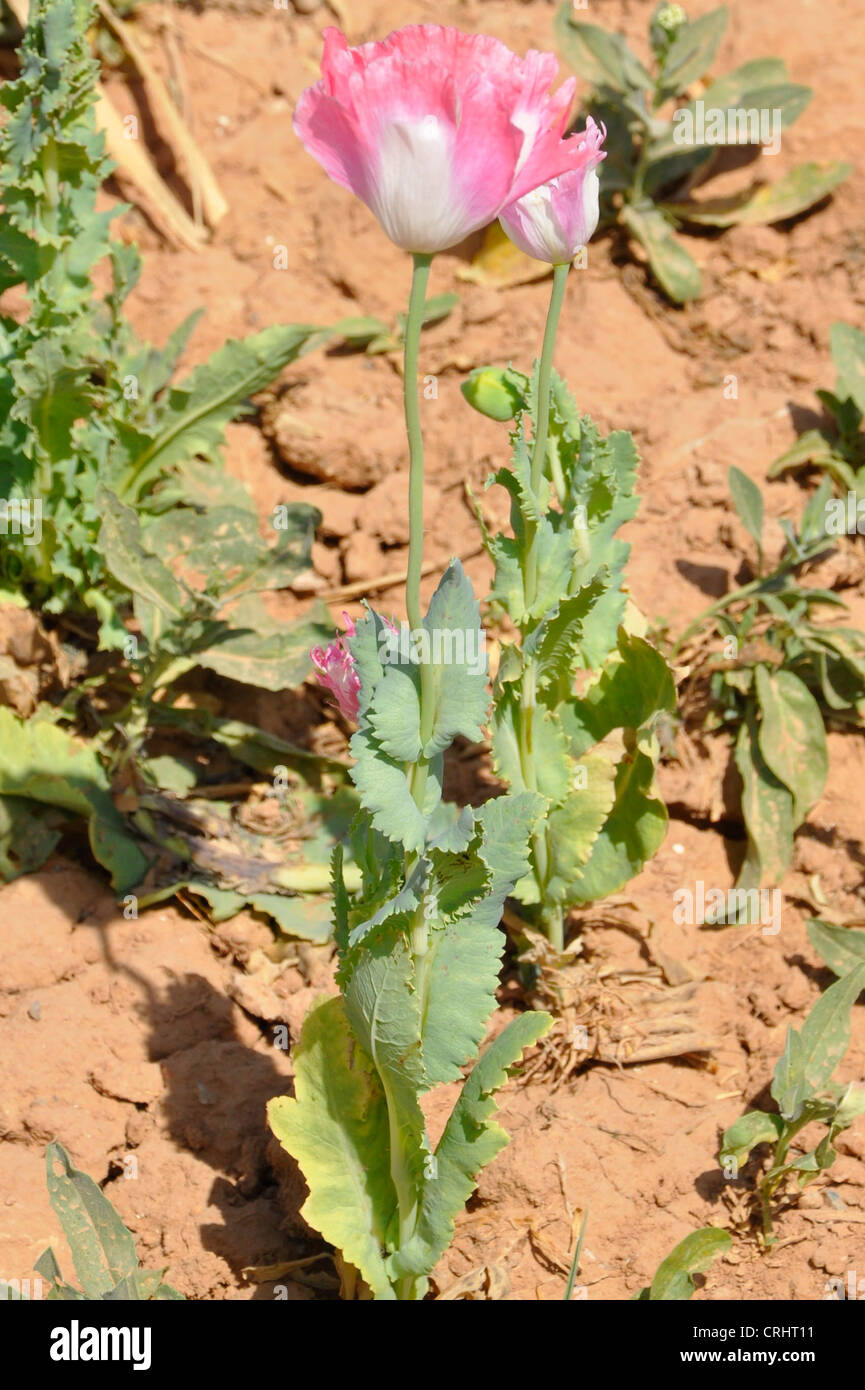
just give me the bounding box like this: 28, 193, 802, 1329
0, 0, 865, 1300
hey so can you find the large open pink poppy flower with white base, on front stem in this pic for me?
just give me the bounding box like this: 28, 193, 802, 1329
295, 24, 584, 254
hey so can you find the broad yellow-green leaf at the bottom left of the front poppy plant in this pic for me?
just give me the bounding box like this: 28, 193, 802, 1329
267, 999, 396, 1298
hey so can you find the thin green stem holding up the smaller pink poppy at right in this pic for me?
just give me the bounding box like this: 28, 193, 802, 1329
520, 263, 570, 949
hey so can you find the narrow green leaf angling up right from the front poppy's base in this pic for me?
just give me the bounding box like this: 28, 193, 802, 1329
389, 1012, 552, 1275
